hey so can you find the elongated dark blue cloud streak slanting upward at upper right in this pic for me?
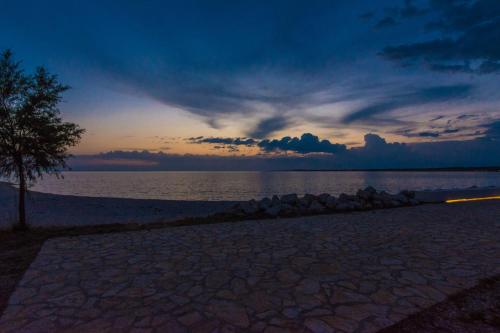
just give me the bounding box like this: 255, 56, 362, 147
342, 84, 474, 124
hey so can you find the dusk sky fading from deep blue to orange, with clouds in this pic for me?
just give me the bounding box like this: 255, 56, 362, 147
0, 0, 500, 169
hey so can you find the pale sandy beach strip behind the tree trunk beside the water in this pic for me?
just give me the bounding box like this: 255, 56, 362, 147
0, 183, 234, 229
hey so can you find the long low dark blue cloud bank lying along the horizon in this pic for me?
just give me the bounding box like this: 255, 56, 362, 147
70, 130, 500, 170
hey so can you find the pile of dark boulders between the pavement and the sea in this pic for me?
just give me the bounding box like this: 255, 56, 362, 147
226, 186, 420, 217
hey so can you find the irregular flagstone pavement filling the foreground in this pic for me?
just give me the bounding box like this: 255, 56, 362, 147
0, 201, 500, 333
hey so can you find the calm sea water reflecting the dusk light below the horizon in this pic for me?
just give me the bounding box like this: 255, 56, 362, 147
28, 171, 500, 200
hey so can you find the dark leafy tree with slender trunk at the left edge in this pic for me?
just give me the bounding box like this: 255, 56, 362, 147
0, 50, 85, 229
